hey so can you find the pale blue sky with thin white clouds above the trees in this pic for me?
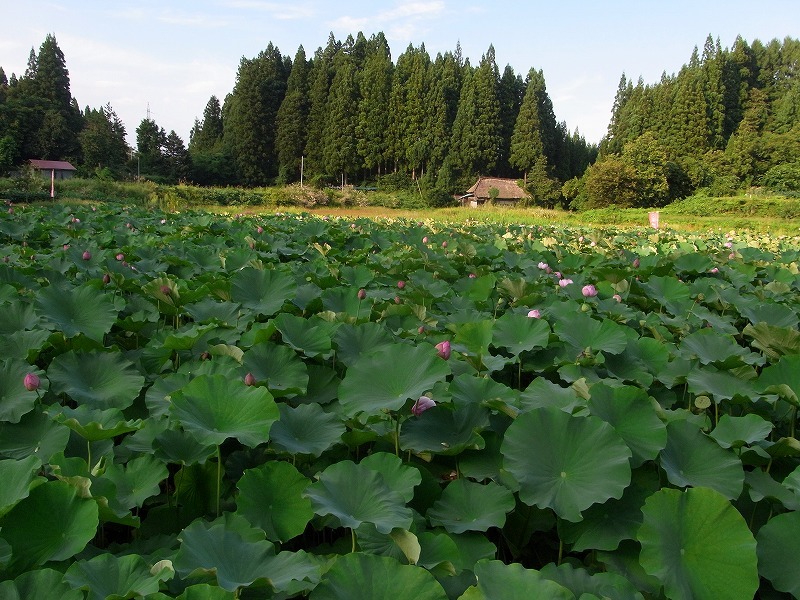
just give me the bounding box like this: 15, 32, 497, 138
0, 0, 800, 144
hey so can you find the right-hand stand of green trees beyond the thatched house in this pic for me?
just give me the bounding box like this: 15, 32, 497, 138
576, 35, 800, 208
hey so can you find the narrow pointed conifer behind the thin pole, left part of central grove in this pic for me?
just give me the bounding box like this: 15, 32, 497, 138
276, 46, 309, 182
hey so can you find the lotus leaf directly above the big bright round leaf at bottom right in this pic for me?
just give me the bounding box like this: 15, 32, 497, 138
660, 421, 744, 500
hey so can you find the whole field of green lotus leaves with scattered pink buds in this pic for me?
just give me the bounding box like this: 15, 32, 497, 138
0, 204, 800, 600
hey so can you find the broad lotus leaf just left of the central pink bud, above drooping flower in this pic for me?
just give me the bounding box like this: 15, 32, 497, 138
339, 344, 450, 417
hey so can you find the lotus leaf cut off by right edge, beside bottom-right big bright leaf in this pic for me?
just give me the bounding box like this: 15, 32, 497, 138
756, 511, 800, 598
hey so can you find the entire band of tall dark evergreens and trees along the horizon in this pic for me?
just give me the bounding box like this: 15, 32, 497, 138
0, 33, 800, 209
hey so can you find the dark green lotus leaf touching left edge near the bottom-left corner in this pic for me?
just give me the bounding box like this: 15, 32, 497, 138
0, 481, 99, 576
